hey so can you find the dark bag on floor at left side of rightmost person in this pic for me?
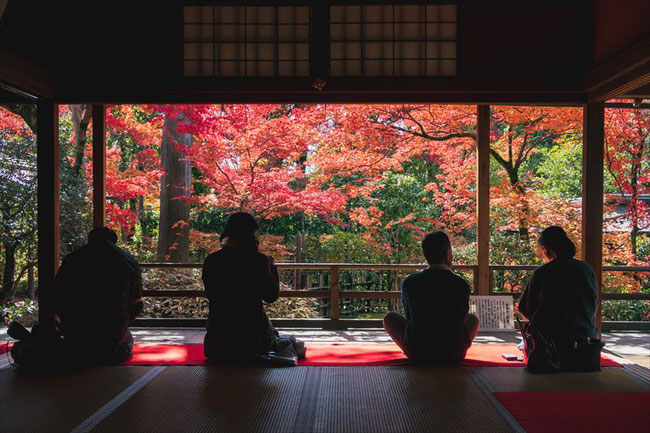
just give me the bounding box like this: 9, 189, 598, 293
517, 319, 560, 374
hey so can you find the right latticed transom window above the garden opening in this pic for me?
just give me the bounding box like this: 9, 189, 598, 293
330, 5, 457, 76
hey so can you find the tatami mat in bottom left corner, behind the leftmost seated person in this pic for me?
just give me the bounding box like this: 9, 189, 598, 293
0, 367, 150, 433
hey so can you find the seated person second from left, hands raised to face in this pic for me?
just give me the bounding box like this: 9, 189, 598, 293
202, 212, 305, 364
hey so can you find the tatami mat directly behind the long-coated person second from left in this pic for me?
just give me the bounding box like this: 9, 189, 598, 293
93, 366, 307, 432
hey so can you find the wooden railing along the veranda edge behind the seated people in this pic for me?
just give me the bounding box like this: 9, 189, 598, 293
141, 263, 650, 321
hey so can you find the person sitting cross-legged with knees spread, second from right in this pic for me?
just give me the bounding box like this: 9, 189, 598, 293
384, 231, 479, 365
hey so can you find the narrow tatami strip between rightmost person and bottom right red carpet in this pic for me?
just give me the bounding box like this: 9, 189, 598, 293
475, 367, 650, 392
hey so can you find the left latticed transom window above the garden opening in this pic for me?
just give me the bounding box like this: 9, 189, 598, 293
183, 6, 310, 77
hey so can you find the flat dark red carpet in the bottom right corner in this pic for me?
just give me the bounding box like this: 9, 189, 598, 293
495, 392, 650, 433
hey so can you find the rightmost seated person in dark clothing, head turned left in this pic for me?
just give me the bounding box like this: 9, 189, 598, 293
519, 226, 598, 365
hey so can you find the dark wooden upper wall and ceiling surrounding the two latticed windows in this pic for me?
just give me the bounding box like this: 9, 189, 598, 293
0, 0, 650, 104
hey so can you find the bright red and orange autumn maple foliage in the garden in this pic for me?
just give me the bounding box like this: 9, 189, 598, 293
0, 104, 650, 308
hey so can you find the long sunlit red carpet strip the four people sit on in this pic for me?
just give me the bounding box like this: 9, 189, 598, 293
119, 343, 620, 367
